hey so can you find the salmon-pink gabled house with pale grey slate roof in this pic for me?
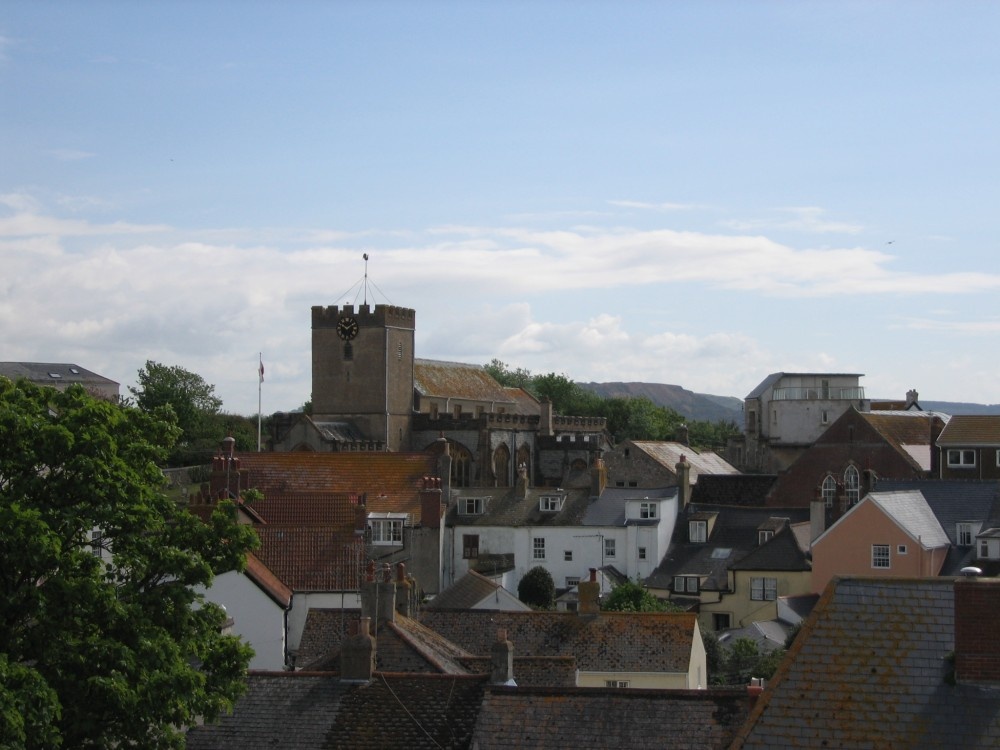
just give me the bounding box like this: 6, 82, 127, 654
812, 490, 950, 592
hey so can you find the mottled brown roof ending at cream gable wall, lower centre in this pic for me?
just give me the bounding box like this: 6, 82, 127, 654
420, 609, 697, 679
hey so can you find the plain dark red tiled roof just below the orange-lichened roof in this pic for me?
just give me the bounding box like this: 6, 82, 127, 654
256, 525, 365, 591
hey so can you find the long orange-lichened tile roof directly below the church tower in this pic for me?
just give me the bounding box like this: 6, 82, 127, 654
237, 452, 437, 518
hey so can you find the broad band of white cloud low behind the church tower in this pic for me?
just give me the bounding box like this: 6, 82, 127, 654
0, 201, 1000, 413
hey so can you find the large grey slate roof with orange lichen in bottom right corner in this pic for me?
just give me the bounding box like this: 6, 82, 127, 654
732, 578, 1000, 749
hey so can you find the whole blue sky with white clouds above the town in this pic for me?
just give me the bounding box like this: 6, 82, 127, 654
0, 0, 1000, 414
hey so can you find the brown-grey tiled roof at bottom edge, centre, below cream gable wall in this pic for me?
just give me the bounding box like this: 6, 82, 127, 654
472, 686, 747, 750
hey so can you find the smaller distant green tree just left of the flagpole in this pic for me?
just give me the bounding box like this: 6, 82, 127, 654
129, 360, 223, 466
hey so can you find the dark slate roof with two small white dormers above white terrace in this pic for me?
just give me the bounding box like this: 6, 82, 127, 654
447, 487, 590, 528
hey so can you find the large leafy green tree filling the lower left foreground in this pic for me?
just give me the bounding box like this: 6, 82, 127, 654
0, 378, 256, 748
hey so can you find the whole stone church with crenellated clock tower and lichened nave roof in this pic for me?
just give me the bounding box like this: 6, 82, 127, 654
272, 305, 610, 488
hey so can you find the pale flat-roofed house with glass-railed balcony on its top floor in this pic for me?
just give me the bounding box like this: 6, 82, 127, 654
727, 372, 871, 474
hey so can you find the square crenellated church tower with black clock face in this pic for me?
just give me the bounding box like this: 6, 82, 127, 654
312, 305, 416, 451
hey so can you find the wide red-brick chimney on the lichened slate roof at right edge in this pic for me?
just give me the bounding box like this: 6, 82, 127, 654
955, 578, 1000, 687
